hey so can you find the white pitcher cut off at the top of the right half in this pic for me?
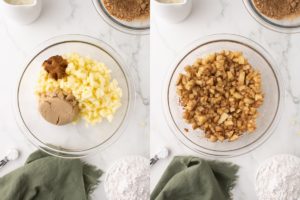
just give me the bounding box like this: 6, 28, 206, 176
153, 0, 192, 23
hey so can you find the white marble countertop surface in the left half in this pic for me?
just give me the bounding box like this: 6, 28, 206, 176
0, 0, 149, 199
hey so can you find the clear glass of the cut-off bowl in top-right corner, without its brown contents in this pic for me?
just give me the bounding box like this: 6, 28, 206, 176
243, 0, 300, 33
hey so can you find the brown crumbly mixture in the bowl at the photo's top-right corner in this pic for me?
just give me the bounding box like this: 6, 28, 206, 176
253, 0, 300, 20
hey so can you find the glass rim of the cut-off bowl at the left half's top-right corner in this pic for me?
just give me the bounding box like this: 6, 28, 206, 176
92, 0, 150, 35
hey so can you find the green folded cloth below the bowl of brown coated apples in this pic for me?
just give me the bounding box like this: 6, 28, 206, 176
151, 156, 239, 200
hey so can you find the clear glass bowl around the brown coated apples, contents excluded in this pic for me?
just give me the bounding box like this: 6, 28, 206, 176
162, 34, 284, 157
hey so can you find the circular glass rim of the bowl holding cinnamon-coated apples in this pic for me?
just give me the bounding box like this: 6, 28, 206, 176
162, 33, 285, 158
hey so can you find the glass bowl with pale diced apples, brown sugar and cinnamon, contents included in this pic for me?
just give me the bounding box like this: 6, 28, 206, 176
14, 35, 135, 158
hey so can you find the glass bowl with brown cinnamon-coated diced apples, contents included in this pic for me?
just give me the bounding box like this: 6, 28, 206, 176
163, 34, 284, 157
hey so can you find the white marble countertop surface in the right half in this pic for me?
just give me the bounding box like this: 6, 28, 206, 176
150, 0, 300, 200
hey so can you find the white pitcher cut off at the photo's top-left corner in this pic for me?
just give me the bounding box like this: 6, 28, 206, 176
0, 0, 42, 24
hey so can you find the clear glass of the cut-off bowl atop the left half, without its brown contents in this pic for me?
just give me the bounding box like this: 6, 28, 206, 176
92, 0, 150, 35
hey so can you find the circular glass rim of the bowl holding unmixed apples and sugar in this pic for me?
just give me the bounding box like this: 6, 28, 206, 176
13, 34, 136, 158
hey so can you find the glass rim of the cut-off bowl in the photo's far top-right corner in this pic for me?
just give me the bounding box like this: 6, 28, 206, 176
243, 0, 300, 34
